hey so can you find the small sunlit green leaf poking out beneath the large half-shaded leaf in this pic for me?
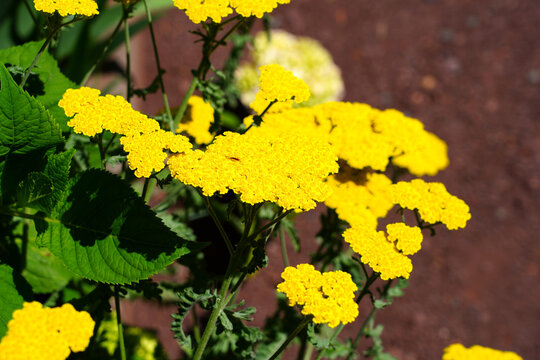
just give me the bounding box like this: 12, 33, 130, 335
23, 241, 73, 294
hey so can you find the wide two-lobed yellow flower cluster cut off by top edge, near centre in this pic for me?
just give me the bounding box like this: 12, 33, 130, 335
173, 0, 291, 24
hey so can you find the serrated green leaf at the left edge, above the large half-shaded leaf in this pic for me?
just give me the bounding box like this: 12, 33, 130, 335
0, 65, 64, 157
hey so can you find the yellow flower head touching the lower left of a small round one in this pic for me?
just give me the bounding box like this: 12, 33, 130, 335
343, 226, 412, 280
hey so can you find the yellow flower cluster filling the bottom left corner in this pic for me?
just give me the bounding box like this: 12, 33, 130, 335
0, 301, 94, 360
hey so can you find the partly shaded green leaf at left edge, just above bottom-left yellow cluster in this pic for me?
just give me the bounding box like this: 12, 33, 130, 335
0, 264, 32, 339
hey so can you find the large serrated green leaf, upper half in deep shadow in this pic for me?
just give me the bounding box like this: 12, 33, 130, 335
36, 169, 190, 284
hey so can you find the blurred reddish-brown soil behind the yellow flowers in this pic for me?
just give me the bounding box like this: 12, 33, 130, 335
126, 0, 540, 360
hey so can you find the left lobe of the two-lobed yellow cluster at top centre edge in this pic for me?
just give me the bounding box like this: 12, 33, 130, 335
173, 0, 232, 24
